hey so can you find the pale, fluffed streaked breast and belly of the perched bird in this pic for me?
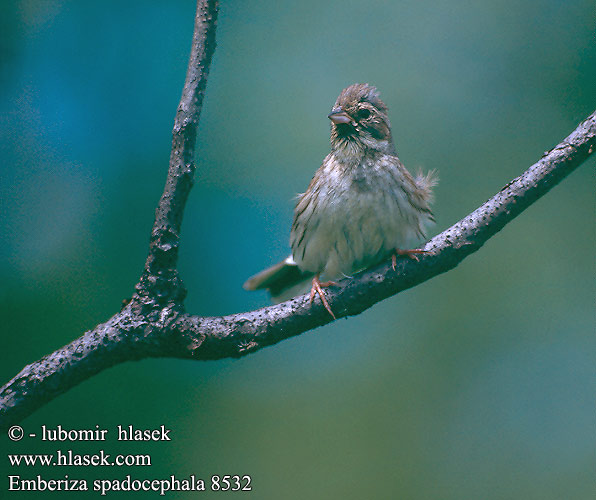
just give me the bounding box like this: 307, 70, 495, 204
290, 157, 418, 279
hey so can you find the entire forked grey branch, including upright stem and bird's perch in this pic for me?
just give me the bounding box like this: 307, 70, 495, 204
0, 0, 596, 428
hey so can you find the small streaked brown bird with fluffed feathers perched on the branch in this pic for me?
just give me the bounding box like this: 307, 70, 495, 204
244, 83, 437, 319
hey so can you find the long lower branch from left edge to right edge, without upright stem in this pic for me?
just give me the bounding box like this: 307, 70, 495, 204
0, 108, 596, 427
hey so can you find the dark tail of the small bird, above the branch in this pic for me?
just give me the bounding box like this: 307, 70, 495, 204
243, 256, 313, 303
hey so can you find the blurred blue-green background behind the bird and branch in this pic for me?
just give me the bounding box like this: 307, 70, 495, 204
0, 0, 596, 500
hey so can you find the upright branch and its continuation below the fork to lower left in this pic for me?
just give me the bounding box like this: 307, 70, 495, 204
0, 0, 218, 426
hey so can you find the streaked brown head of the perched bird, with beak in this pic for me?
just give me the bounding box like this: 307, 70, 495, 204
329, 83, 394, 154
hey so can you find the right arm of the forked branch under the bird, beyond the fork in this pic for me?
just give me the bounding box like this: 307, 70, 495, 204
175, 111, 596, 359
